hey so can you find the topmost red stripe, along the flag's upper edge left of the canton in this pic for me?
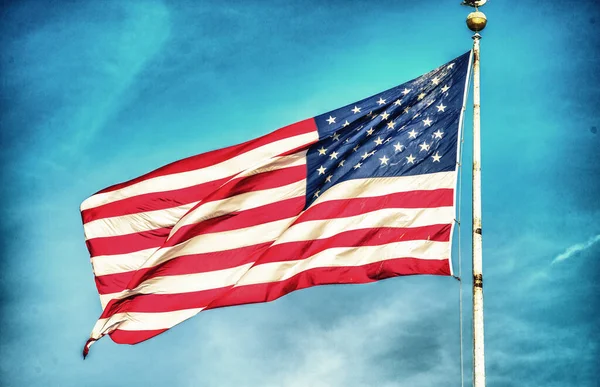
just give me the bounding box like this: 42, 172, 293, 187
97, 118, 317, 194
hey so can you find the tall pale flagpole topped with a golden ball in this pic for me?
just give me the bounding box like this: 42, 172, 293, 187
465, 0, 487, 387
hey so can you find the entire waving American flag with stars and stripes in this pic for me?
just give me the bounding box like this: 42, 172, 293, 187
81, 52, 471, 356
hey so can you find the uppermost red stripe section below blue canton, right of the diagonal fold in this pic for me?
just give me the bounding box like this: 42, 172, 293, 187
294, 188, 454, 224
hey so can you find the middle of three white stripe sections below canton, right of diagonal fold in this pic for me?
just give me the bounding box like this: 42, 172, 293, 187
274, 207, 454, 244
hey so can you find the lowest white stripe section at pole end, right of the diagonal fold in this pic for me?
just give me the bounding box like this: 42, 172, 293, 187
236, 240, 450, 286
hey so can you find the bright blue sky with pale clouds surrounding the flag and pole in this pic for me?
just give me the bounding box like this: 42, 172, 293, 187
0, 0, 600, 387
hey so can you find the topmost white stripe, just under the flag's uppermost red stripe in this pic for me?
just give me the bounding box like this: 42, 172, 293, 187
81, 131, 318, 211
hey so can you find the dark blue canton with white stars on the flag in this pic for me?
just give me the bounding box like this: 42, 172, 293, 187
306, 52, 470, 207
